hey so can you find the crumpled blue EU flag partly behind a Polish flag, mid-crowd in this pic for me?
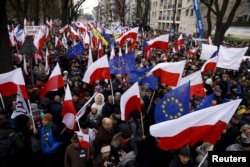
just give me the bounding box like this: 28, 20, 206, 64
127, 66, 159, 90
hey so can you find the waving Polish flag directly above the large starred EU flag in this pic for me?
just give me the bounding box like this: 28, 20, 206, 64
148, 60, 186, 87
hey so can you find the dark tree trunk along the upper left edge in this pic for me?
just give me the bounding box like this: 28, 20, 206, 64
0, 0, 13, 73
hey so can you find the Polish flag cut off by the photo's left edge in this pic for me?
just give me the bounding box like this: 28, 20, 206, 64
0, 68, 28, 99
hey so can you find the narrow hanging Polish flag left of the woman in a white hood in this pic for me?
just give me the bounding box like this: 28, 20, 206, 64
62, 84, 76, 130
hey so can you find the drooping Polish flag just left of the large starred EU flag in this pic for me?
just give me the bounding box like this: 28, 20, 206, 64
120, 82, 142, 121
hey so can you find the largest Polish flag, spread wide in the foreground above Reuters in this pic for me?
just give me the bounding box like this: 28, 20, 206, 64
150, 99, 242, 150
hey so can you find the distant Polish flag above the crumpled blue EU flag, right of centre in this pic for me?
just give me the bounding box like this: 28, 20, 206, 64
145, 34, 169, 53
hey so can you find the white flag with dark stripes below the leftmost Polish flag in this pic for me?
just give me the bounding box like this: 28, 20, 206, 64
11, 85, 29, 119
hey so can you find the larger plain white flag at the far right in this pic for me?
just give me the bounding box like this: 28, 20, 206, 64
217, 45, 248, 70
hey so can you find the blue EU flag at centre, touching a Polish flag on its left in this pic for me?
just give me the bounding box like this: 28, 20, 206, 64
109, 52, 135, 74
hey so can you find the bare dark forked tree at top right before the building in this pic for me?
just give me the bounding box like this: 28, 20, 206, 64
200, 0, 242, 46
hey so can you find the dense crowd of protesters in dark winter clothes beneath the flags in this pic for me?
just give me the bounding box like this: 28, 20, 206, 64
0, 22, 250, 167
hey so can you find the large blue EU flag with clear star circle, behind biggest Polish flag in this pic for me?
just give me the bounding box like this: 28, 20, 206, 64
154, 82, 190, 123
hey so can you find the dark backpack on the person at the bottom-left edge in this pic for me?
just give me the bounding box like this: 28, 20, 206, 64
0, 131, 15, 161
